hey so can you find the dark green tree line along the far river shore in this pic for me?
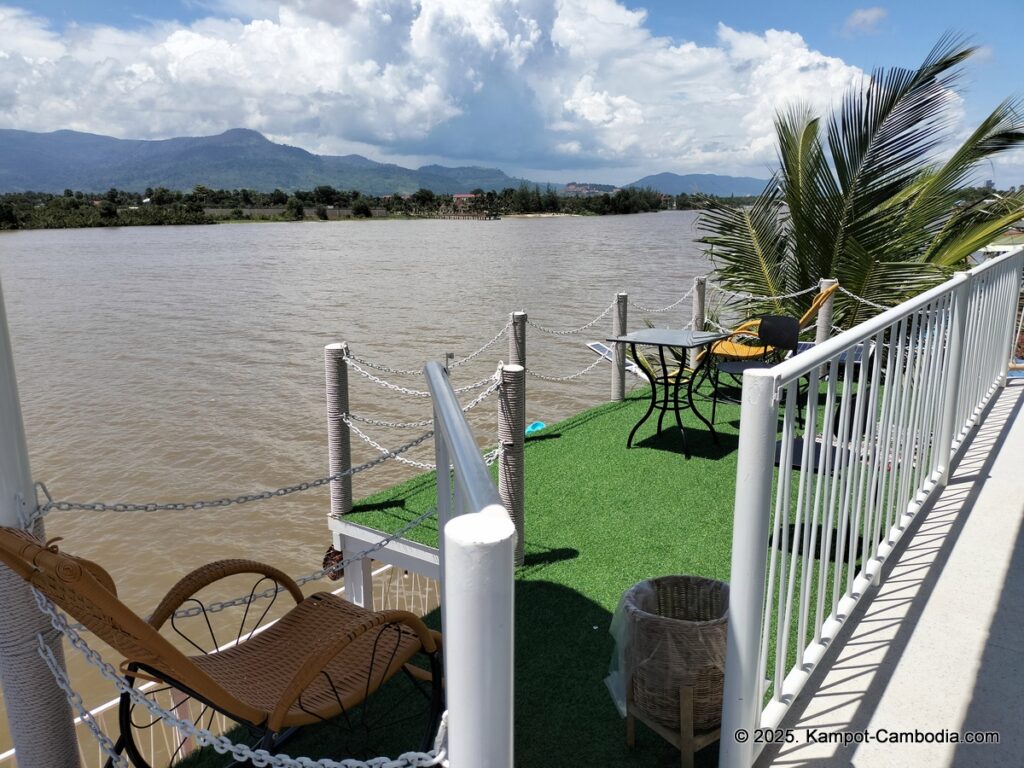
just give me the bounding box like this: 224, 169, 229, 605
0, 183, 751, 229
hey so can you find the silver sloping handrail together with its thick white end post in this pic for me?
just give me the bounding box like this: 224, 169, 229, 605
424, 362, 516, 768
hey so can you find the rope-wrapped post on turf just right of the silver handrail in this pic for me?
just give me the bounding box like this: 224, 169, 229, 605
498, 366, 526, 565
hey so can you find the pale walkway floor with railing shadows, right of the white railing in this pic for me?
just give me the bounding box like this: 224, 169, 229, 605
758, 380, 1024, 768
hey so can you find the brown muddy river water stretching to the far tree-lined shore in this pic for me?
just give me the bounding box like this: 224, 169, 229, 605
0, 212, 710, 753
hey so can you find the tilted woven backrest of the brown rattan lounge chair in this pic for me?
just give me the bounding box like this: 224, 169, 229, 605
0, 526, 247, 720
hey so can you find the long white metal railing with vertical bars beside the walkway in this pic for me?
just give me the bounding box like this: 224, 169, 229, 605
721, 249, 1024, 768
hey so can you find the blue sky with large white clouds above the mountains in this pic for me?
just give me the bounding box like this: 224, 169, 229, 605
0, 0, 1024, 186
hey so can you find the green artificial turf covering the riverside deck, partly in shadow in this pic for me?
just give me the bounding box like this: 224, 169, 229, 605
180, 391, 739, 768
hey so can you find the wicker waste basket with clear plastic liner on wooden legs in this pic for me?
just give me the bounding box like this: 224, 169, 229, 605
606, 575, 729, 765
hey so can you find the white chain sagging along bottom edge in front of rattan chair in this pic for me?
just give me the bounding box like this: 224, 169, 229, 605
34, 590, 447, 768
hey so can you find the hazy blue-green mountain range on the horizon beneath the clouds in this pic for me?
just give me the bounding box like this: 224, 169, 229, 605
0, 128, 766, 196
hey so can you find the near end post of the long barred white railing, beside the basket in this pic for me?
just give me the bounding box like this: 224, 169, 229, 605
719, 371, 778, 768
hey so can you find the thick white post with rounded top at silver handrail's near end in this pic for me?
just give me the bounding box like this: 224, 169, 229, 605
443, 504, 516, 768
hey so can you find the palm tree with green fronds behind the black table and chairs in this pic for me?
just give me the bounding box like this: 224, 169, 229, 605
698, 36, 1024, 328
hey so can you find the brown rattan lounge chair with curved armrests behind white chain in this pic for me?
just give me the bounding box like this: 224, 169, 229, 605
0, 526, 443, 768
